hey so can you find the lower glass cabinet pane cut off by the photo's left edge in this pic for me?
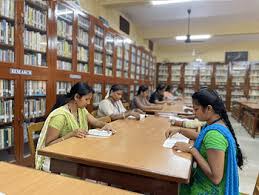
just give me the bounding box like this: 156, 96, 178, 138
0, 79, 15, 161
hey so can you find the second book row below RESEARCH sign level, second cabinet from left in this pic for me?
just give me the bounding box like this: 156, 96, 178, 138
24, 98, 46, 119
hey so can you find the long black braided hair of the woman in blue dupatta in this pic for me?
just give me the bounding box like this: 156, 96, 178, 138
192, 88, 244, 168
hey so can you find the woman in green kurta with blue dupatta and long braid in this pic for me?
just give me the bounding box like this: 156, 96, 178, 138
166, 89, 243, 195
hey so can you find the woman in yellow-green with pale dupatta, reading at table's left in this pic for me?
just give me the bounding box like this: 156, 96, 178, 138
35, 82, 112, 171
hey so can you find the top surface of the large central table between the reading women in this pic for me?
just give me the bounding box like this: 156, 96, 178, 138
39, 116, 192, 183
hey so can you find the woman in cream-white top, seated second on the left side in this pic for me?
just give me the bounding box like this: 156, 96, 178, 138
97, 85, 140, 121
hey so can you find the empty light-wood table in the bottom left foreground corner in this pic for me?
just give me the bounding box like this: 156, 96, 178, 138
0, 162, 138, 195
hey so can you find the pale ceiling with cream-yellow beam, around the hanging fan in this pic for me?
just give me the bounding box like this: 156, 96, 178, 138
100, 0, 259, 45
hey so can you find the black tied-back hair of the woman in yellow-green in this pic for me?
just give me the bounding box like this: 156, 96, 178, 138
52, 82, 94, 110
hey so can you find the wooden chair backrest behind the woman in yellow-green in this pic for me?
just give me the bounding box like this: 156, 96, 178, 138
27, 122, 44, 159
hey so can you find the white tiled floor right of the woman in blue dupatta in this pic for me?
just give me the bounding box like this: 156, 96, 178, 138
229, 114, 259, 195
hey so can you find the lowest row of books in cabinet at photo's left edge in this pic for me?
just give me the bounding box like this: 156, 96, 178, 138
0, 127, 14, 150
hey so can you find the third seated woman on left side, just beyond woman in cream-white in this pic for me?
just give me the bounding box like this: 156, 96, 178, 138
131, 85, 162, 112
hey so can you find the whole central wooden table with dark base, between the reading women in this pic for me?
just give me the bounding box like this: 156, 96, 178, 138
39, 116, 192, 195
